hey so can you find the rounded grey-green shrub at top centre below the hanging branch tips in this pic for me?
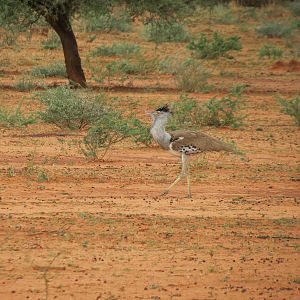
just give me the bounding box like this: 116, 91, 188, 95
143, 20, 190, 44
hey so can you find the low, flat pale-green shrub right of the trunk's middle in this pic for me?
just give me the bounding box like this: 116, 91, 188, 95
92, 43, 141, 56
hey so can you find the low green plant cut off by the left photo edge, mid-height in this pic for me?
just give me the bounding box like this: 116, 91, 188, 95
0, 103, 36, 127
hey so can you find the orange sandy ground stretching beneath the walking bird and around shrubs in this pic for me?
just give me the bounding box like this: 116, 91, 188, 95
0, 5, 300, 300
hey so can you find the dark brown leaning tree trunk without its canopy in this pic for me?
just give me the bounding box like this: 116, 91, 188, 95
45, 13, 87, 87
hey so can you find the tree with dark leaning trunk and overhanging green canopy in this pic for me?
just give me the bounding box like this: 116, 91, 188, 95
0, 0, 196, 87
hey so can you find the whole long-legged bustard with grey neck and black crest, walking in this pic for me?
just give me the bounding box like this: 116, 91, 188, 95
150, 106, 233, 197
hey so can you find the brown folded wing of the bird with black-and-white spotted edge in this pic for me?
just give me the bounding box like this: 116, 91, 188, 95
170, 130, 233, 154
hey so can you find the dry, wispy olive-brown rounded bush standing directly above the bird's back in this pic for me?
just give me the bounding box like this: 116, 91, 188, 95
174, 59, 210, 92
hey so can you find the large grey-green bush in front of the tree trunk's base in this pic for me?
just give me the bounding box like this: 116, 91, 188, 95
39, 87, 104, 129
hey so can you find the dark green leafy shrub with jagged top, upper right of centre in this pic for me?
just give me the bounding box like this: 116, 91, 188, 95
188, 32, 242, 59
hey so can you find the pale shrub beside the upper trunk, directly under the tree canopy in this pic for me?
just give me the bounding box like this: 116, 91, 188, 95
84, 12, 132, 32
